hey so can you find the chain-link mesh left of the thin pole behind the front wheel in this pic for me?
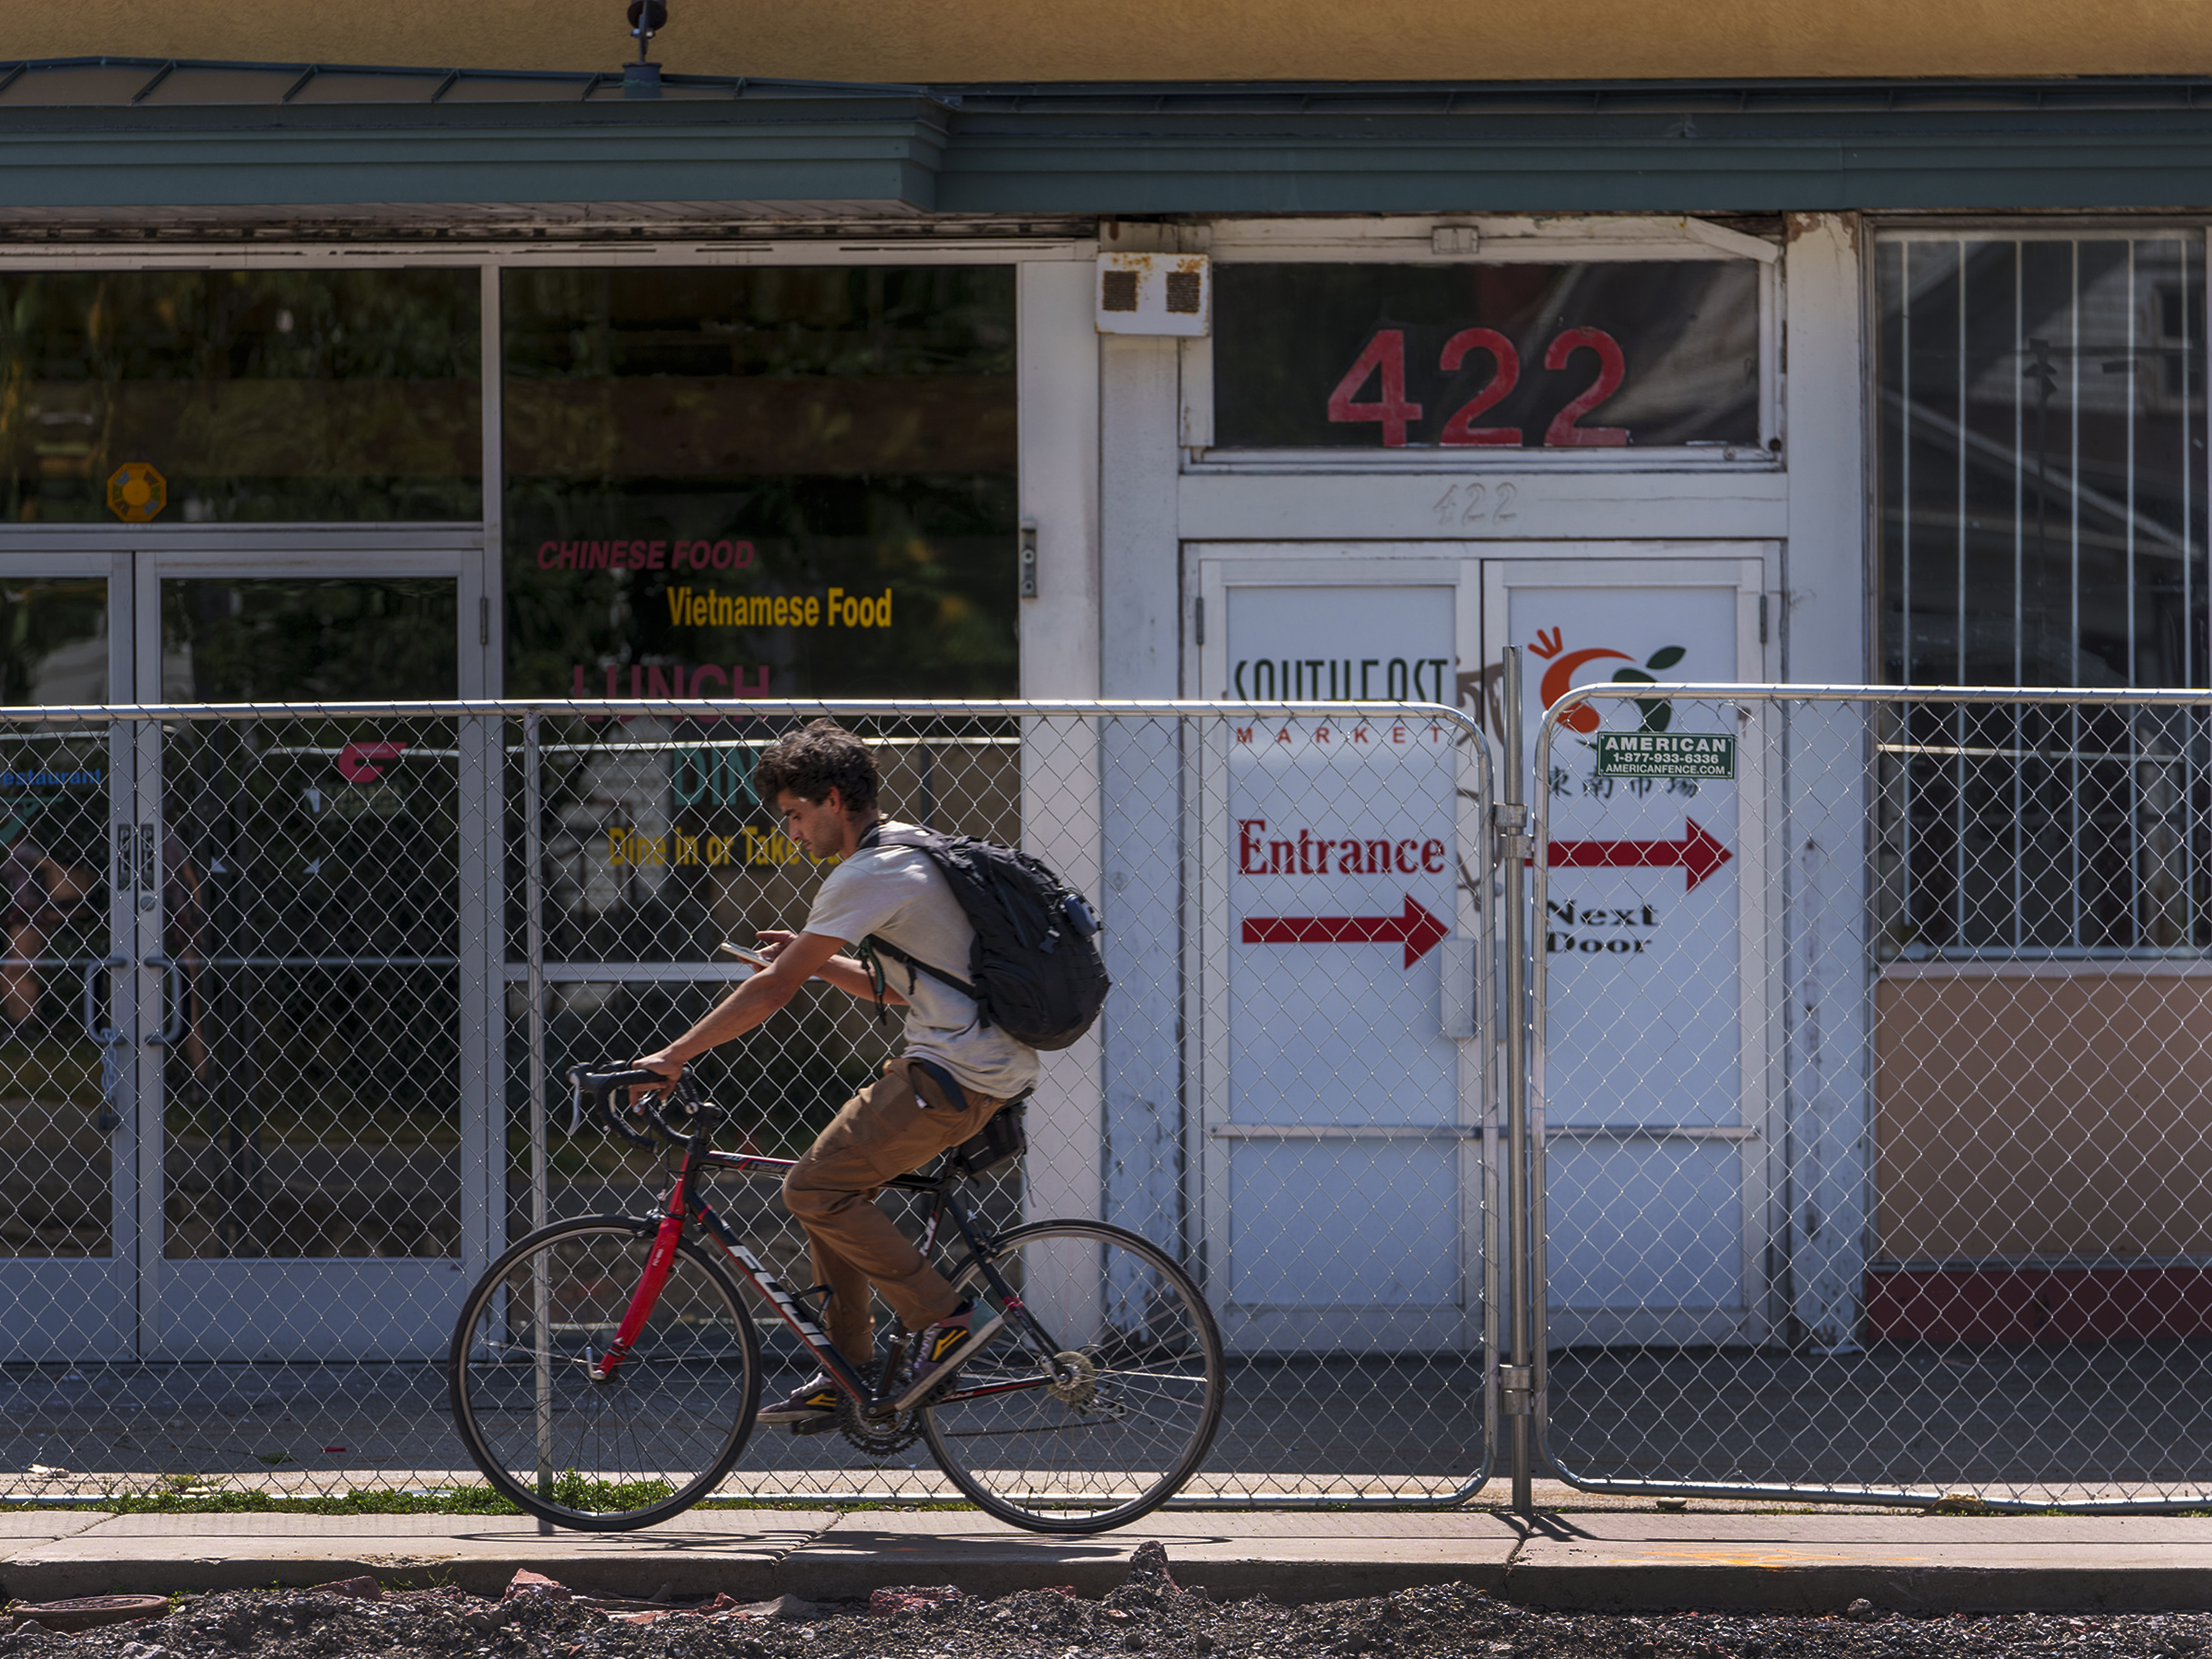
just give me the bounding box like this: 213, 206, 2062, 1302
0, 706, 500, 1498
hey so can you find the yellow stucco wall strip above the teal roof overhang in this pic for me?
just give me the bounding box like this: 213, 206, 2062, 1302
17, 0, 2212, 82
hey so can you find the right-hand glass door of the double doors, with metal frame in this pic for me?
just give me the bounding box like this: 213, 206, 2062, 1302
137, 555, 496, 1360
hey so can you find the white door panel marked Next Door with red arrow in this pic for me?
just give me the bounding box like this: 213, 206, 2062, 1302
1484, 547, 1771, 1347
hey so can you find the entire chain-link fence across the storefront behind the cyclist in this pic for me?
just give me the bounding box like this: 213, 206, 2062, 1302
26, 684, 2212, 1506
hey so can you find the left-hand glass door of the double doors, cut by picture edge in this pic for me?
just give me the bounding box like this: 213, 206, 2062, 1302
0, 553, 139, 1360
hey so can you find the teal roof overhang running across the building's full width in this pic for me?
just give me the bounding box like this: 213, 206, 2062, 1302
13, 60, 2212, 230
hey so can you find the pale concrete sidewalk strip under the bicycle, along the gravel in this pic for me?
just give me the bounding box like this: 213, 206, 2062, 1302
0, 1488, 2212, 1613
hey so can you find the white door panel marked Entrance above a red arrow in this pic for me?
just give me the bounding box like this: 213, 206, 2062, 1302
1185, 544, 1482, 1351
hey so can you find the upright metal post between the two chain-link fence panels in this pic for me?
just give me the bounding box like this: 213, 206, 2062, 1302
1495, 646, 1535, 1515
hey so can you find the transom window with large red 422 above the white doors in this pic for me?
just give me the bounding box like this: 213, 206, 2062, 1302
1215, 259, 1760, 449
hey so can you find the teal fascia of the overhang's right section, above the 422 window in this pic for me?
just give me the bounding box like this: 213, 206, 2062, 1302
938, 100, 2212, 215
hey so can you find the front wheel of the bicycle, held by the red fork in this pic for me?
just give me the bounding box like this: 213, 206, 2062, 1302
447, 1217, 761, 1533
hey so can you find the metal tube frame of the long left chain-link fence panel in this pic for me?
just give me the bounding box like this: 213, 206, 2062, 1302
0, 699, 1495, 1509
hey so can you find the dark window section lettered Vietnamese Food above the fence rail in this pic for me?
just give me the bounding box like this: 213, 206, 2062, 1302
502, 265, 1018, 697
